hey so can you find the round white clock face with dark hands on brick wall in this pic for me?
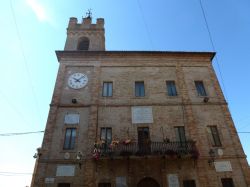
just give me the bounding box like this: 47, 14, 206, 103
68, 73, 88, 89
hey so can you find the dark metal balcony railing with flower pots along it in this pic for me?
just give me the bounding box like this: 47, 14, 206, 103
95, 141, 199, 159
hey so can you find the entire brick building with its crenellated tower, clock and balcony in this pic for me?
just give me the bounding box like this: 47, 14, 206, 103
31, 18, 250, 187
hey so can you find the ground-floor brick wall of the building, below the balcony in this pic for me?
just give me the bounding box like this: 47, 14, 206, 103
33, 156, 247, 187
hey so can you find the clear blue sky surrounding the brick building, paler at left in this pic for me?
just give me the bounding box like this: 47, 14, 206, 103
0, 0, 250, 187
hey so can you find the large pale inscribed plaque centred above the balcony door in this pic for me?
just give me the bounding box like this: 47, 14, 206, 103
132, 106, 153, 124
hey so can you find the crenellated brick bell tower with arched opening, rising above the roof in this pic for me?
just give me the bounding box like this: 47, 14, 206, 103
64, 14, 105, 51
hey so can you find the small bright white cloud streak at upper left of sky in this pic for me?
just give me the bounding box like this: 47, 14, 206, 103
25, 0, 50, 22
